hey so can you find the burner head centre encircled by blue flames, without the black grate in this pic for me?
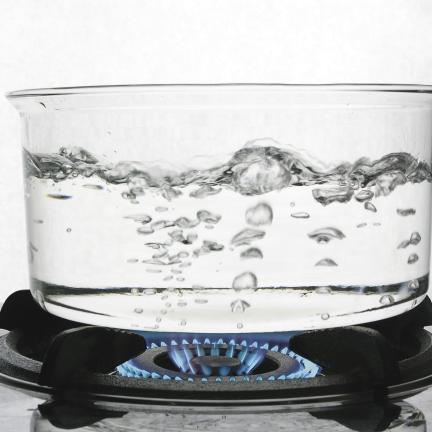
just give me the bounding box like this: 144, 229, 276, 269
117, 337, 321, 382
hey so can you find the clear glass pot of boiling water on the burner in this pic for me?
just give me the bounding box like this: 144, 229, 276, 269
8, 85, 432, 333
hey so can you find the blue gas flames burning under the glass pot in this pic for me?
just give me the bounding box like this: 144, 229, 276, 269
117, 332, 322, 382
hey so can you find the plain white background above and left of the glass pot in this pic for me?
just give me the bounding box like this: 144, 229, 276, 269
0, 0, 432, 301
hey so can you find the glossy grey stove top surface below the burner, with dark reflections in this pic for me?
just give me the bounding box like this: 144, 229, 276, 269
0, 380, 432, 432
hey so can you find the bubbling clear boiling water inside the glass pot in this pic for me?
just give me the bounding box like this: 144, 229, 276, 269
25, 139, 431, 333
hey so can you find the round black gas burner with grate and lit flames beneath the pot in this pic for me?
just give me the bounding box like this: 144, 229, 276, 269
0, 291, 432, 413
